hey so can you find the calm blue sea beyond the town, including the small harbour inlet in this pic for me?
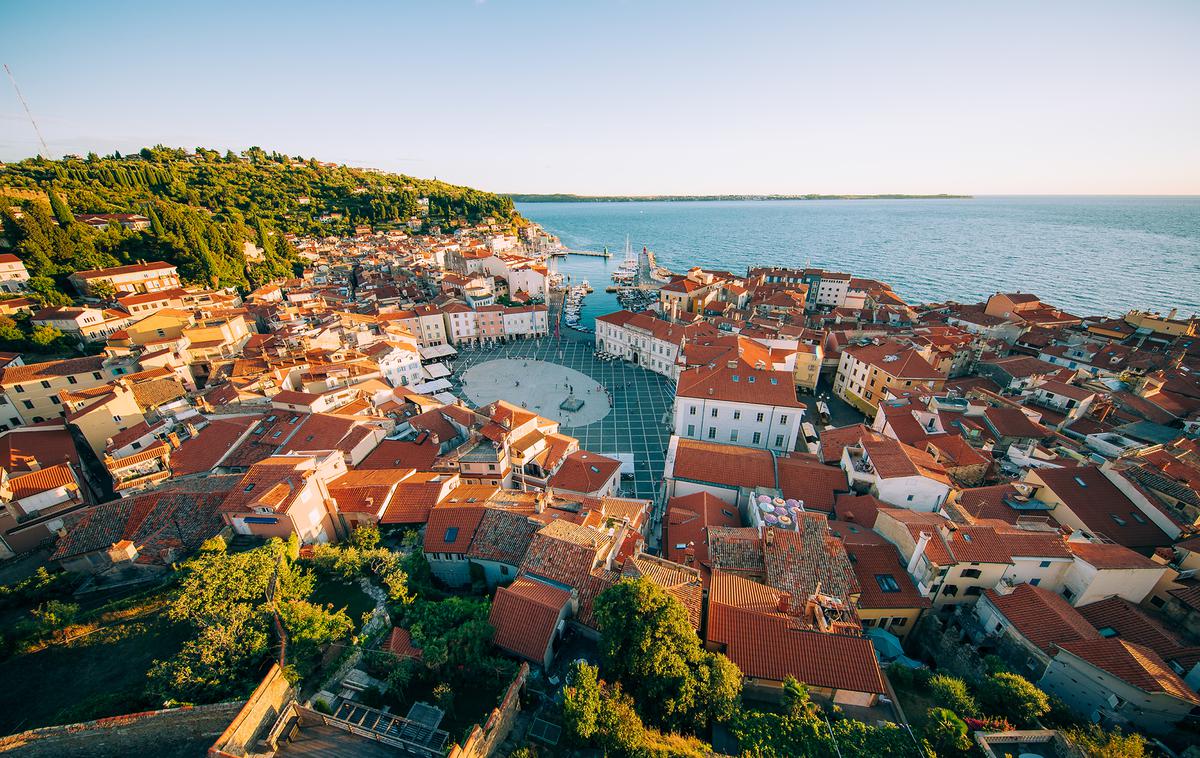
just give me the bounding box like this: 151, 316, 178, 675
518, 197, 1200, 318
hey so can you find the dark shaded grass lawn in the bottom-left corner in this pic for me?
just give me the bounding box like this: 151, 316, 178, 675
0, 615, 187, 734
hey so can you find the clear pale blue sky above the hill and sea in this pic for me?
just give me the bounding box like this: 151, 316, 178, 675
0, 0, 1200, 194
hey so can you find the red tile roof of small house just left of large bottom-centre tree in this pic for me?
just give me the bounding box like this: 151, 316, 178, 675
487, 577, 571, 663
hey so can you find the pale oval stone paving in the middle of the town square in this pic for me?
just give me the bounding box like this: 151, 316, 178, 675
461, 359, 612, 427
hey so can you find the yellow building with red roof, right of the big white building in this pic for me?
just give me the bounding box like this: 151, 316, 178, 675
833, 341, 946, 416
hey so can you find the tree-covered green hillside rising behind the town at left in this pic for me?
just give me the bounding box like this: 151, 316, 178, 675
0, 146, 524, 302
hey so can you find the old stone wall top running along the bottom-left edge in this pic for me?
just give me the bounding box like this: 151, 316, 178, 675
0, 702, 242, 758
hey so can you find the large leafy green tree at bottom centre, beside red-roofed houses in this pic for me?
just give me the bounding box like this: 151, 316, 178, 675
595, 579, 742, 729
